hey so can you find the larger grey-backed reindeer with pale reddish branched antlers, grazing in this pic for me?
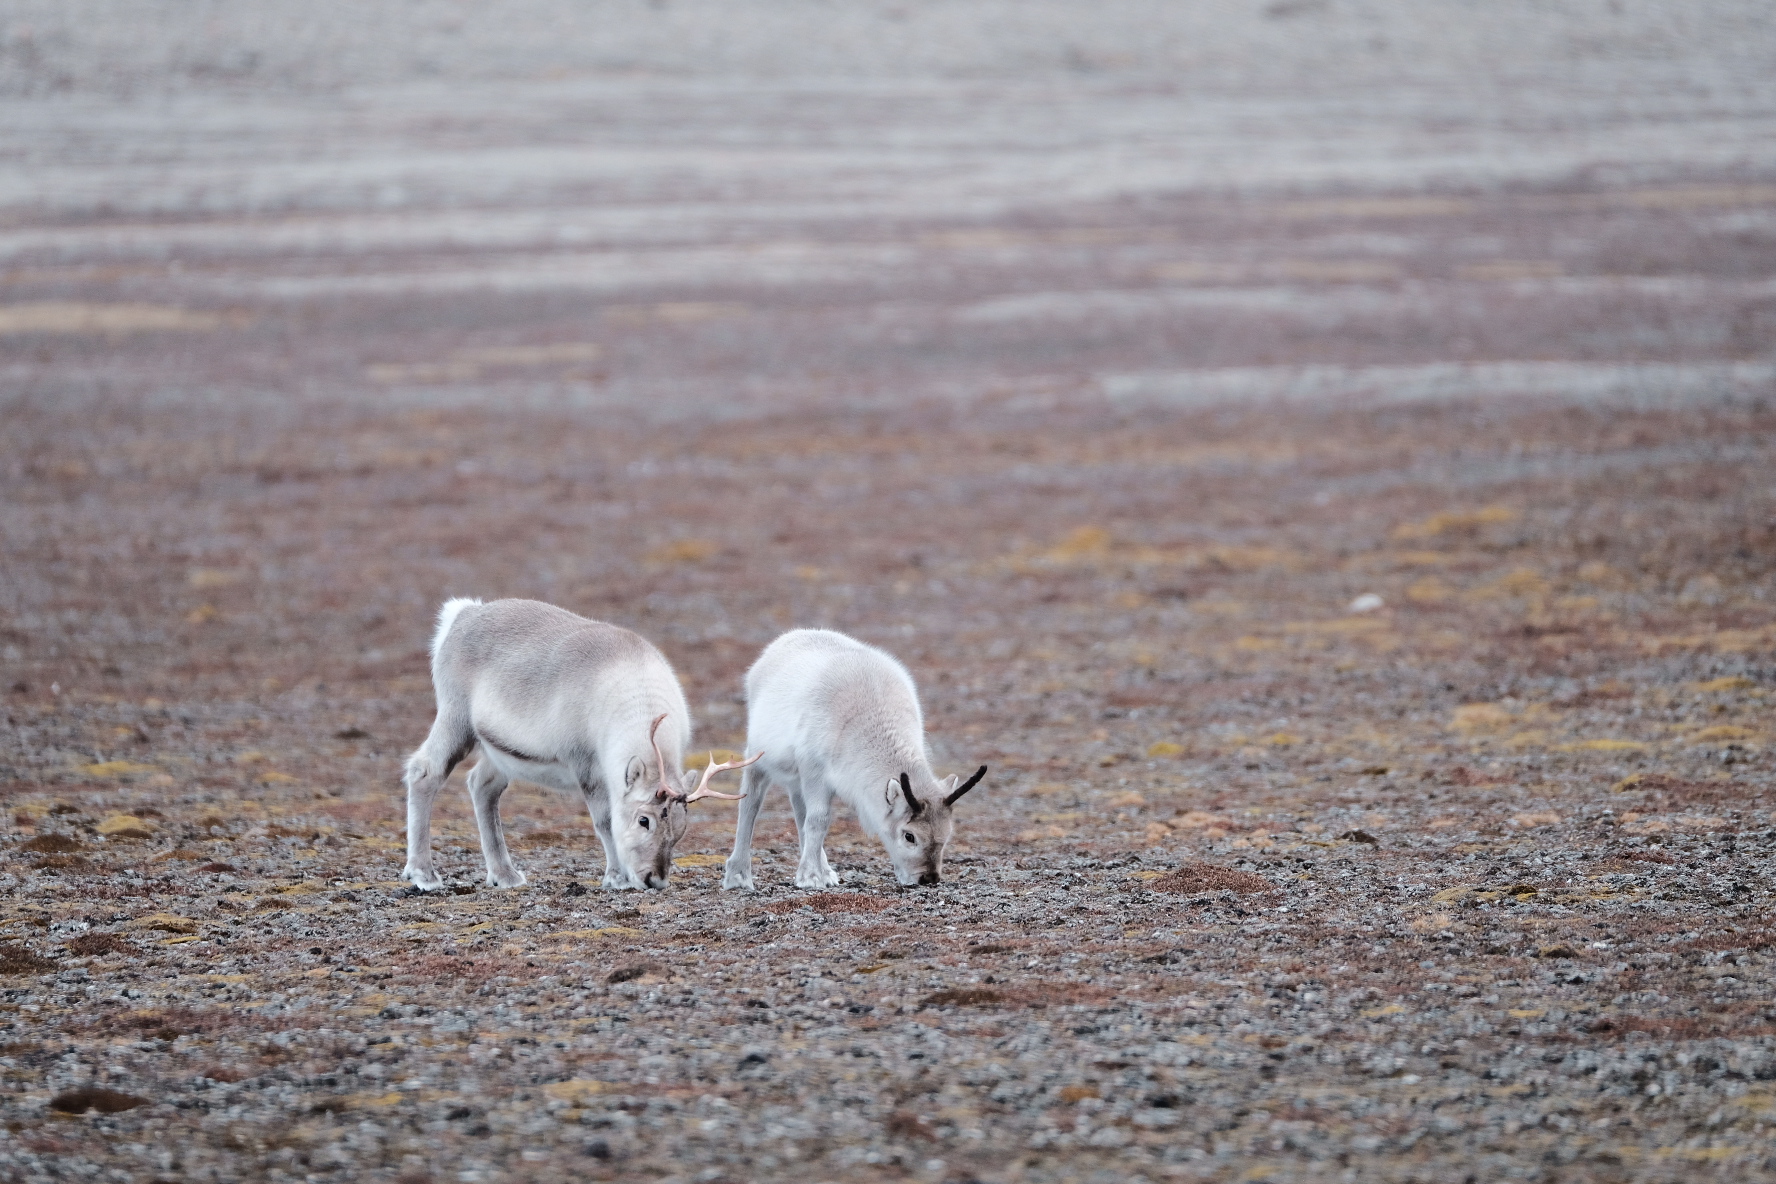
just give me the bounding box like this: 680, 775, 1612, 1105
401, 600, 758, 891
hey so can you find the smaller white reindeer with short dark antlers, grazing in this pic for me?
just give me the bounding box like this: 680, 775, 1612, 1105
721, 628, 987, 888
